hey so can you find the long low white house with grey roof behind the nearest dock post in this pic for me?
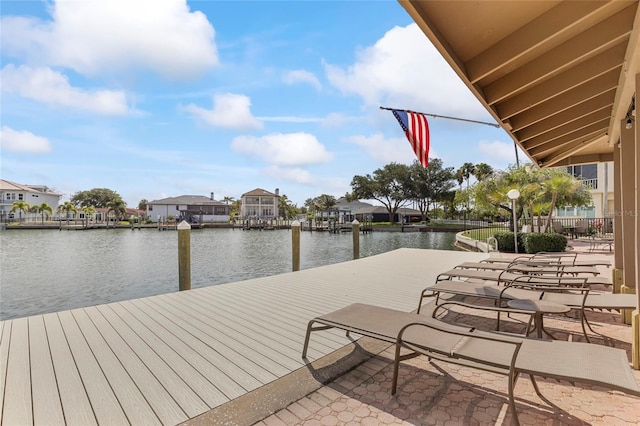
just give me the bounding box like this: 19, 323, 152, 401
146, 192, 229, 223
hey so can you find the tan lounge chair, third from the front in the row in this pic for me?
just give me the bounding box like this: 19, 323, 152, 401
436, 268, 613, 287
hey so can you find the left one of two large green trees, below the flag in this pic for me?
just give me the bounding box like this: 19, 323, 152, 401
351, 163, 411, 222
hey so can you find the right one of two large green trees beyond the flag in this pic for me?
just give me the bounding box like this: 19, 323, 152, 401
407, 158, 455, 221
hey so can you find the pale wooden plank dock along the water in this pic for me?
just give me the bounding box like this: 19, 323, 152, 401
0, 249, 486, 425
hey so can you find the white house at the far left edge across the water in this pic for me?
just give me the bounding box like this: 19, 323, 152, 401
0, 179, 62, 221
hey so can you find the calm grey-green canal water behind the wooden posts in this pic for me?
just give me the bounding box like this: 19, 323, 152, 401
0, 229, 455, 320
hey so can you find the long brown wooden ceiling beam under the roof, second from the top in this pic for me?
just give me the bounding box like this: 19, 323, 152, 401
483, 7, 635, 105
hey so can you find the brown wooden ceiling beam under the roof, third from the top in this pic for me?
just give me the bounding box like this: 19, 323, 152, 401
497, 43, 627, 117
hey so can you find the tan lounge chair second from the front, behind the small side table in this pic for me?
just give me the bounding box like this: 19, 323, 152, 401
417, 278, 636, 342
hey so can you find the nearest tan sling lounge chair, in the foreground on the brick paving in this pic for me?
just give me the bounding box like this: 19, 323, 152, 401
302, 304, 640, 424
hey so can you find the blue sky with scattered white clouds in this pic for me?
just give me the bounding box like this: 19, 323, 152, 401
0, 0, 524, 207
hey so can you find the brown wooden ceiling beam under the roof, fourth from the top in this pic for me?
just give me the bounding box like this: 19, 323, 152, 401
504, 74, 620, 131
